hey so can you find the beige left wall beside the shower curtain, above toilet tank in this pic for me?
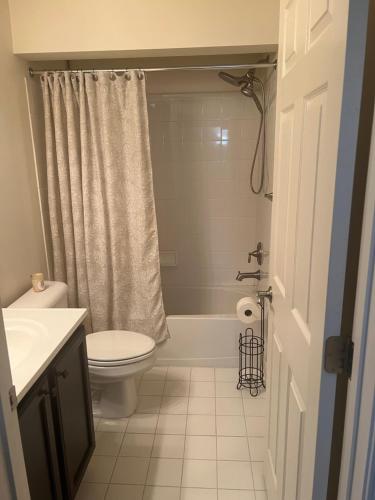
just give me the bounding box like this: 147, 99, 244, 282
0, 0, 45, 306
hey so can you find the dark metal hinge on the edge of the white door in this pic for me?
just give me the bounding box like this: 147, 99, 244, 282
324, 336, 354, 378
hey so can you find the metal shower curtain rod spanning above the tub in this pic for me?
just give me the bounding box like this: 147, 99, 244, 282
29, 61, 277, 77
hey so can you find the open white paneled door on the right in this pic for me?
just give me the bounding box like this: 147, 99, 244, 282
265, 0, 350, 500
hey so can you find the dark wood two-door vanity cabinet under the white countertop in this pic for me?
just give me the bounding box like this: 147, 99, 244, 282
18, 328, 95, 500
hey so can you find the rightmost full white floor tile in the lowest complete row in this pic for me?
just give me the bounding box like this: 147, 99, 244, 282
217, 460, 254, 490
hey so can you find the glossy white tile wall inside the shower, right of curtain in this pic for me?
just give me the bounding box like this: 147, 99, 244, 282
148, 92, 259, 314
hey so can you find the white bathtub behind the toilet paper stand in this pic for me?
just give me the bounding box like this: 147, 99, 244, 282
157, 287, 260, 367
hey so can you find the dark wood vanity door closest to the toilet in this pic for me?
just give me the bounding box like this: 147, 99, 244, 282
50, 329, 95, 499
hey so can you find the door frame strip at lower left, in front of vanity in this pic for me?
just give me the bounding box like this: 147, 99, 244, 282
0, 307, 30, 500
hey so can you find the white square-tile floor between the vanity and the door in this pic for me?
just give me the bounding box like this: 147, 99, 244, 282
77, 366, 267, 500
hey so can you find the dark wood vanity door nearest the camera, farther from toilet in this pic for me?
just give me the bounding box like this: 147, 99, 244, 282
18, 377, 63, 500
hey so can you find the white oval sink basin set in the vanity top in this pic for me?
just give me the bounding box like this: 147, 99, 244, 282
4, 318, 48, 371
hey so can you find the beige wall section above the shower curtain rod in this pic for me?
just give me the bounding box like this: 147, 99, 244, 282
9, 0, 279, 59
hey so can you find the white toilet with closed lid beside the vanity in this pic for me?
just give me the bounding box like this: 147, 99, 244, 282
9, 281, 157, 418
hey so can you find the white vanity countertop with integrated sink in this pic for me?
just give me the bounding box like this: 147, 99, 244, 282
2, 308, 87, 402
